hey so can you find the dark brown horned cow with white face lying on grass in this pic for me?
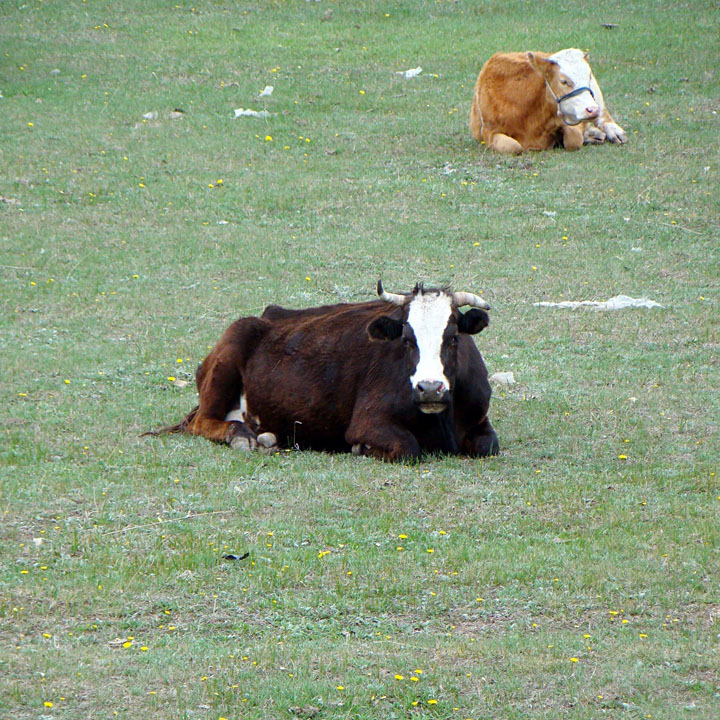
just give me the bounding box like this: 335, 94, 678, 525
143, 283, 498, 460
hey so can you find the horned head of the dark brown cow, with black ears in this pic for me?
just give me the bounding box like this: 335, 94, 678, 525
367, 282, 490, 413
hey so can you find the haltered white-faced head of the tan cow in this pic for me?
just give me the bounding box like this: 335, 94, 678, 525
528, 48, 600, 125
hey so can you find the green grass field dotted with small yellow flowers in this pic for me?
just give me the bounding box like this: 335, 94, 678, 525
0, 0, 720, 720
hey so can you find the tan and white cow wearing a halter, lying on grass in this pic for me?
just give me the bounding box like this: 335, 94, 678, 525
470, 48, 627, 154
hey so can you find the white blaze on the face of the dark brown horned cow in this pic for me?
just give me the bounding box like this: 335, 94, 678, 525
407, 293, 452, 389
